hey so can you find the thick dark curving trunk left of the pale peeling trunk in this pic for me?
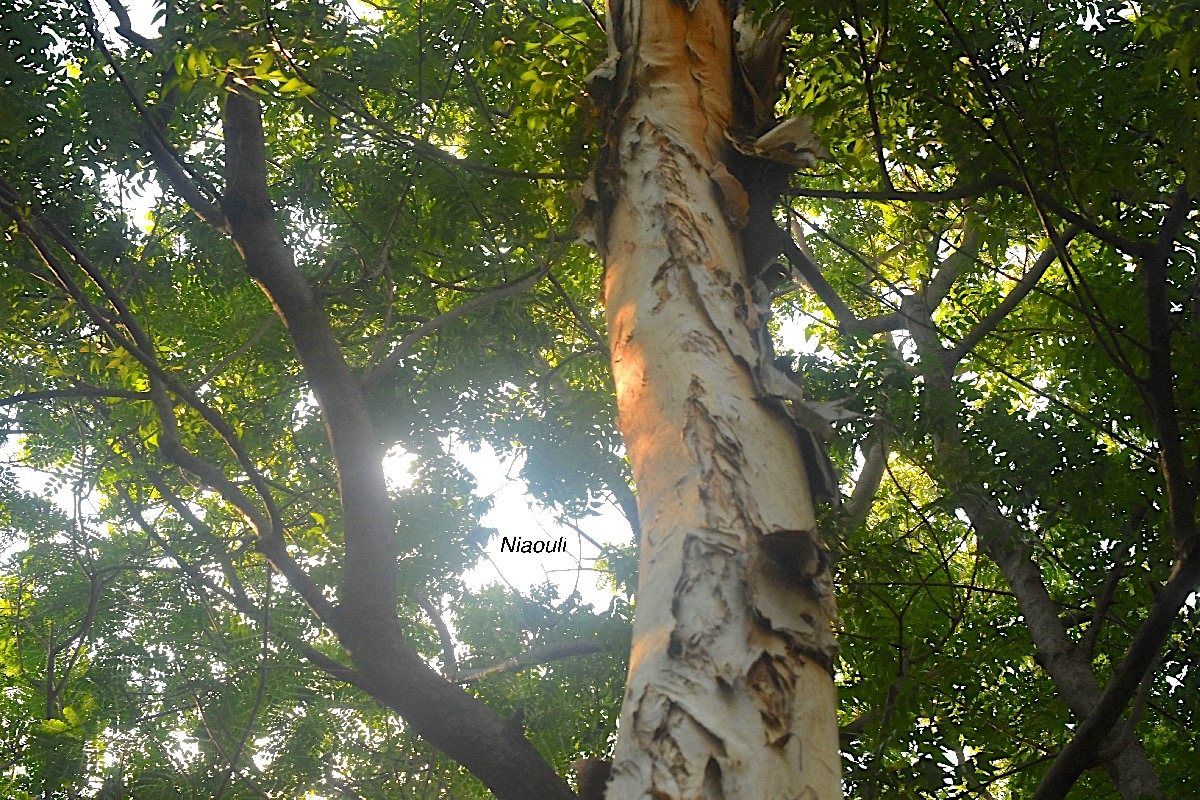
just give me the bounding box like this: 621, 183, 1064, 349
221, 87, 572, 800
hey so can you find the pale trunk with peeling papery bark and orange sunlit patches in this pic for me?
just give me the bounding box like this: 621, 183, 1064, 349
592, 0, 841, 800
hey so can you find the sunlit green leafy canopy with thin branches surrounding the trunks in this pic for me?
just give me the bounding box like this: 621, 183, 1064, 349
0, 0, 1200, 799
